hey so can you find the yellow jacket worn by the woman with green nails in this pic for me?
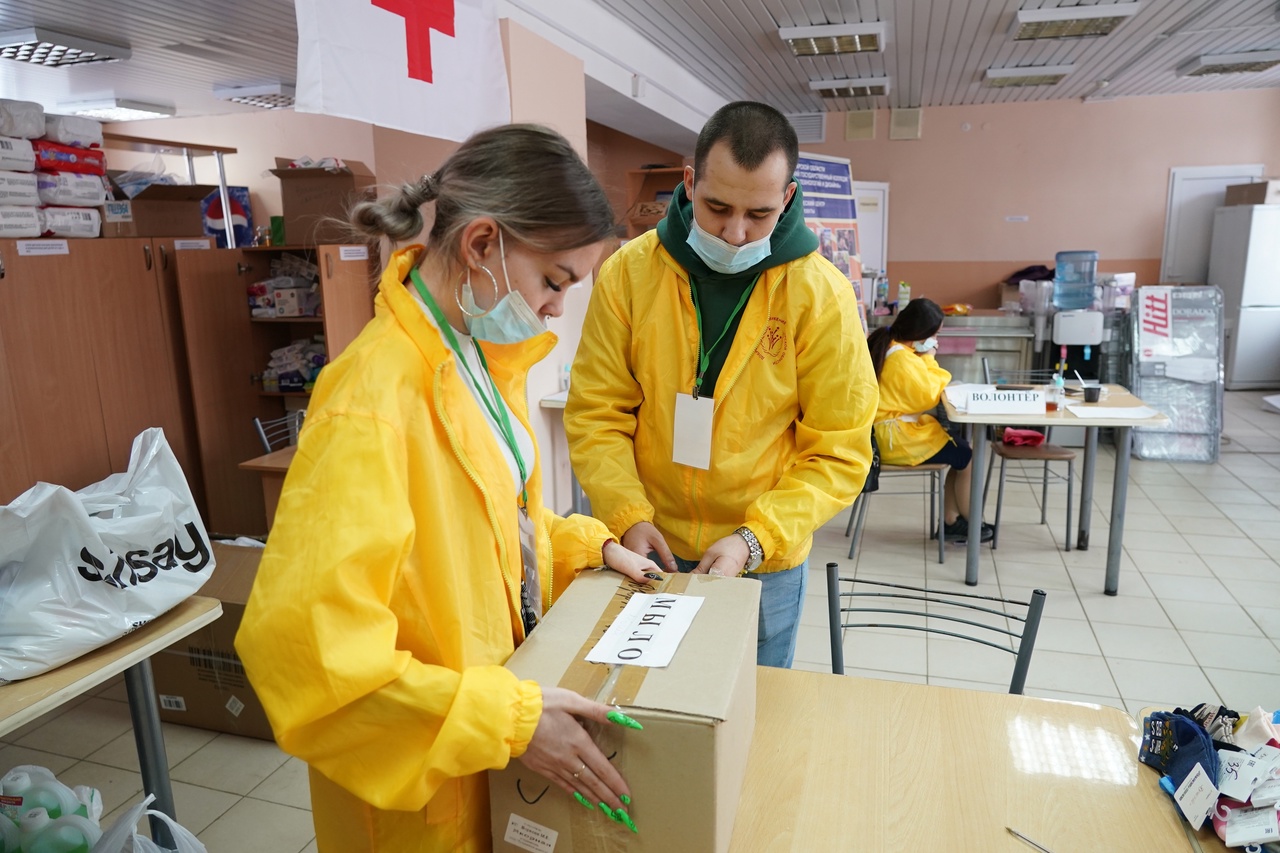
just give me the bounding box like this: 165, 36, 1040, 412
236, 247, 609, 853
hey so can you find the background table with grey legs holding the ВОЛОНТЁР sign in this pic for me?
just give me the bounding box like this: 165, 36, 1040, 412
942, 386, 1169, 596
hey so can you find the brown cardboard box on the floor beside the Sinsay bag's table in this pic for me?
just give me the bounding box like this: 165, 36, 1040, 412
151, 542, 274, 740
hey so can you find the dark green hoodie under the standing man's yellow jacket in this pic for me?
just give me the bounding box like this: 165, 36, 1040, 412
658, 182, 818, 392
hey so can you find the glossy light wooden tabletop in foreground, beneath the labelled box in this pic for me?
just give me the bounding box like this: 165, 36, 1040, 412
737, 667, 1193, 853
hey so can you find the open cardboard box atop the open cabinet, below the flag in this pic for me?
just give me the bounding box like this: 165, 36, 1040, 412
271, 158, 375, 246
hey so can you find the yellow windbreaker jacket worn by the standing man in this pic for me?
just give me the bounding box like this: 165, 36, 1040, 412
564, 231, 876, 571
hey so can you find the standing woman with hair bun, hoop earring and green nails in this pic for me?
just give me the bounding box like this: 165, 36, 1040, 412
236, 126, 659, 853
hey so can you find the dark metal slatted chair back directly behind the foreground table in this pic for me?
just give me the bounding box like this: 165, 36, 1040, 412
827, 562, 1046, 693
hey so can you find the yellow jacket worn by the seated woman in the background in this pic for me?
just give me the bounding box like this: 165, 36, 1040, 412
876, 345, 951, 465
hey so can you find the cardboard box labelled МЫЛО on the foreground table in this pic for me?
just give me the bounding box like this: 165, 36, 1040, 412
489, 573, 760, 853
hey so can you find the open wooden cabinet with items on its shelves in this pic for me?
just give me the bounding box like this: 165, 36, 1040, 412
174, 246, 375, 534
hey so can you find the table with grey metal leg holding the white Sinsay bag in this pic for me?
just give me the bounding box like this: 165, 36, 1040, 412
0, 596, 223, 847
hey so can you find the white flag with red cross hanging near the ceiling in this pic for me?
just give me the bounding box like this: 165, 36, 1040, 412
294, 0, 511, 140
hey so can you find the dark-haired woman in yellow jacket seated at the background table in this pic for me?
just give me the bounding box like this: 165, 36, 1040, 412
867, 298, 995, 542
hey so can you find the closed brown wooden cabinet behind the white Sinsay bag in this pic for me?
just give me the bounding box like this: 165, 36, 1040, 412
0, 238, 192, 503
